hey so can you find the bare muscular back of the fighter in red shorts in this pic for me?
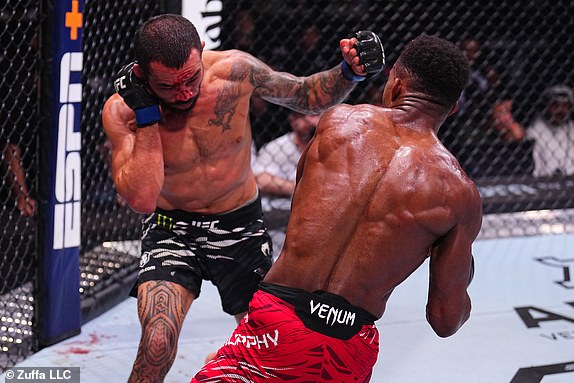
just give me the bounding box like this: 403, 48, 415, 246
266, 105, 480, 317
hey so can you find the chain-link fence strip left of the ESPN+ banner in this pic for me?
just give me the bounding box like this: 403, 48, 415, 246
0, 0, 43, 371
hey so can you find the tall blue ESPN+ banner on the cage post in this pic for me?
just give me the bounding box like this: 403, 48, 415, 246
39, 0, 84, 345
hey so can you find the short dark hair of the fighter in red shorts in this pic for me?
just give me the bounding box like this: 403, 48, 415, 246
396, 34, 469, 106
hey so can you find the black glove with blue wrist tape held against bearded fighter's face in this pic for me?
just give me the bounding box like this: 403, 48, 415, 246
114, 62, 161, 127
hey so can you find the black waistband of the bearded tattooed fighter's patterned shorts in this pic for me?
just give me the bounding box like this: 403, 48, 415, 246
155, 195, 263, 227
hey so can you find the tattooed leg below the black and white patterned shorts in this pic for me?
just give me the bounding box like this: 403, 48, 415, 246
128, 281, 194, 383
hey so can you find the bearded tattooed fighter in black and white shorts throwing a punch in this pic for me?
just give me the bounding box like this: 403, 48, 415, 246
102, 14, 384, 382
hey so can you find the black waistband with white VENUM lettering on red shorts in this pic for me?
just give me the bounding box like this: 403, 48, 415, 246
259, 282, 377, 339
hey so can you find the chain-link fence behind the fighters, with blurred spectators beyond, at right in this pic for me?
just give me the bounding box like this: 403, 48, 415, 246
221, 0, 574, 237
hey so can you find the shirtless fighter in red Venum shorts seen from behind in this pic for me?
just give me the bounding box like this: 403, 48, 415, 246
192, 35, 482, 383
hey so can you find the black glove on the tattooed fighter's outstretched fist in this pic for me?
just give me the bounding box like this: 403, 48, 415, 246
341, 31, 385, 82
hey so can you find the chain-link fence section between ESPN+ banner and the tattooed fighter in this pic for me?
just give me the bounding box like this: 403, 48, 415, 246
80, 0, 165, 328
